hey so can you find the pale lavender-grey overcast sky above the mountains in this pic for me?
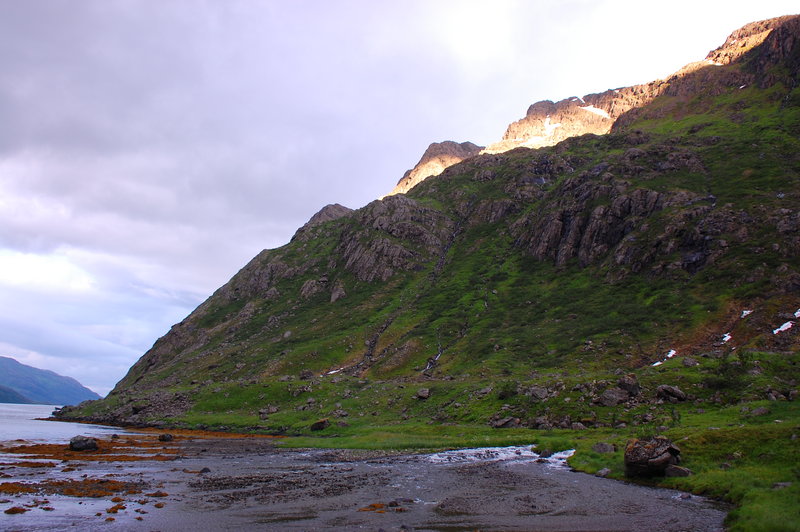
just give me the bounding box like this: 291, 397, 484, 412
0, 0, 800, 394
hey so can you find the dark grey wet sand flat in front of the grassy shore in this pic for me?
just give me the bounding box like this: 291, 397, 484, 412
0, 435, 727, 531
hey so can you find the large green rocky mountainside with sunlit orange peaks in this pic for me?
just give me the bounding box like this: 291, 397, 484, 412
61, 17, 800, 434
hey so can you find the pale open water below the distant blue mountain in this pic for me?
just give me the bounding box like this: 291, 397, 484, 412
0, 403, 134, 443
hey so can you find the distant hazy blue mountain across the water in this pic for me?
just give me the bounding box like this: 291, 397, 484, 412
0, 357, 100, 405
